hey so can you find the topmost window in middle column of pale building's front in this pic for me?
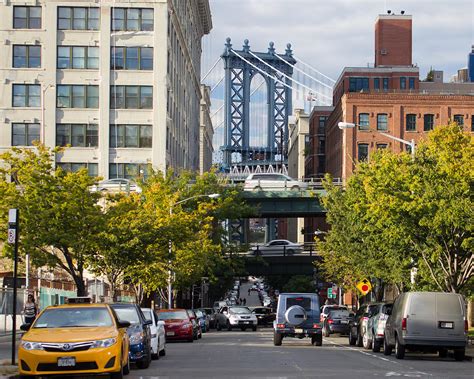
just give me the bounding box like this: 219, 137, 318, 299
58, 7, 100, 30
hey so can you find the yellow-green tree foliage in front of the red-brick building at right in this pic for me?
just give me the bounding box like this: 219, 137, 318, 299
319, 124, 474, 292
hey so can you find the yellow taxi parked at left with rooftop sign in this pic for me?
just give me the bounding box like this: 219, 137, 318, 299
18, 298, 130, 379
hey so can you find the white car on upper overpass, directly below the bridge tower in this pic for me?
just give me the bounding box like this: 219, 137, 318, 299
244, 173, 308, 191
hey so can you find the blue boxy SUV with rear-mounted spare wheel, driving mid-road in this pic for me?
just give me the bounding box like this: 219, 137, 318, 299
273, 293, 323, 346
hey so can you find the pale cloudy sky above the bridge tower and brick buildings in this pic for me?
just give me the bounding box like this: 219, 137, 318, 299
202, 0, 474, 159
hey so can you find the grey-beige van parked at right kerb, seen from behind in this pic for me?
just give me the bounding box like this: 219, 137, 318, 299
384, 292, 468, 361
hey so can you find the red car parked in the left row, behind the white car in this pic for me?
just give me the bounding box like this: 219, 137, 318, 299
158, 308, 194, 342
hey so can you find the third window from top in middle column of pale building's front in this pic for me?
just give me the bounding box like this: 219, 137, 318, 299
56, 85, 99, 108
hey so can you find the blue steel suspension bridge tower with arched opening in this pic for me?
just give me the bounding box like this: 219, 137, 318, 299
221, 38, 296, 173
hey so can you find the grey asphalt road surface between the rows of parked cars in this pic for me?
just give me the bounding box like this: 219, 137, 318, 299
128, 328, 474, 379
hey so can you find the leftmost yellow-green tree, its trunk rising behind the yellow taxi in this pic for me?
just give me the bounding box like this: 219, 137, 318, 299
0, 144, 103, 296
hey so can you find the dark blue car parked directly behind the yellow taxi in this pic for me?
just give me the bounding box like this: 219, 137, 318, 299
110, 303, 152, 369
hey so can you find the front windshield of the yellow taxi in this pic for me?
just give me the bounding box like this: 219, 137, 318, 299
34, 307, 113, 329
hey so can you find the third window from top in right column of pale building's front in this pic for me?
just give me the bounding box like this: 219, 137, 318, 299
110, 86, 153, 109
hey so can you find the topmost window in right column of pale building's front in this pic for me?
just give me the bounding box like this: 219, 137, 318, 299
112, 8, 153, 31
